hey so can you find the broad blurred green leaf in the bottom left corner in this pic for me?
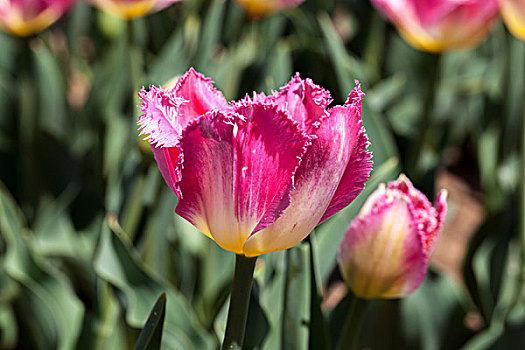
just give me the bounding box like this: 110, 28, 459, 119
0, 183, 84, 350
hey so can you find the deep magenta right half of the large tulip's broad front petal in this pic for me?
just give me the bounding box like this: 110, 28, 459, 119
236, 103, 310, 233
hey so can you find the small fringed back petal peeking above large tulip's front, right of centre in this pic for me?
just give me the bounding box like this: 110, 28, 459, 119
274, 74, 332, 135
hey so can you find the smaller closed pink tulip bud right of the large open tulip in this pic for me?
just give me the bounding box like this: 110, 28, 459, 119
338, 175, 447, 299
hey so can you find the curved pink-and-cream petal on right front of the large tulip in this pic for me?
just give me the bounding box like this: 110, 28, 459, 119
244, 84, 371, 256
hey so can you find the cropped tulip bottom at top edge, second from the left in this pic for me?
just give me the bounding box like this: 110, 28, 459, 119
91, 0, 181, 19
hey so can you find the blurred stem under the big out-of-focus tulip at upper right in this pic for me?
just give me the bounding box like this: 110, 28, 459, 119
407, 53, 441, 179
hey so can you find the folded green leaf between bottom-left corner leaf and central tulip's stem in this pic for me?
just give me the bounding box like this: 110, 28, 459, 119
94, 217, 213, 349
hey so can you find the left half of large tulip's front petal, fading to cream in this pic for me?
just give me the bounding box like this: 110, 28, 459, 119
175, 114, 239, 252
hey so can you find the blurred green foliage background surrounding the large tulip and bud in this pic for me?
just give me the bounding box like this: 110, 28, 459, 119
0, 0, 525, 350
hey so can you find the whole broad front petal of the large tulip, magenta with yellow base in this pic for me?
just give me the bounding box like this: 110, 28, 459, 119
176, 105, 309, 254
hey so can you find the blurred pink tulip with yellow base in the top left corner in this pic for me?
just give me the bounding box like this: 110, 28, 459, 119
0, 0, 76, 36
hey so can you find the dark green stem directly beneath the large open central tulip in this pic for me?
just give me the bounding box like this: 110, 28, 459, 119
222, 255, 257, 350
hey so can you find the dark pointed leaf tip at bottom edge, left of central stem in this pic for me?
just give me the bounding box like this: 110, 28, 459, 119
135, 293, 166, 350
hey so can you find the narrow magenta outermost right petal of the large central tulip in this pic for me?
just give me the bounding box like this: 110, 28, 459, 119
319, 85, 372, 223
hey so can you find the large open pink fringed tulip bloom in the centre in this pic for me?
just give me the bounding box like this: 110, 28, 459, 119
138, 69, 372, 256
